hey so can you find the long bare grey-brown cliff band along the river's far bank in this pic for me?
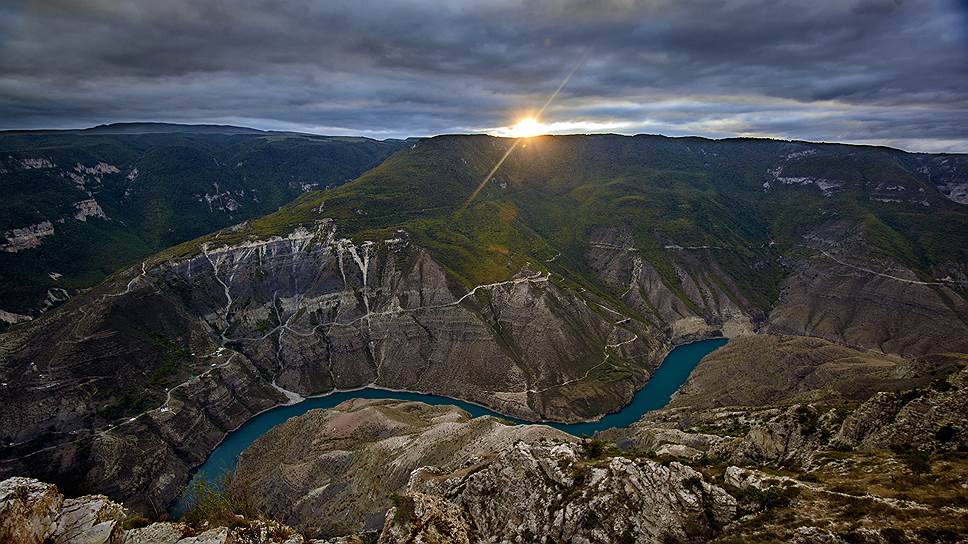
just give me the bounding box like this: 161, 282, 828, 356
0, 222, 656, 510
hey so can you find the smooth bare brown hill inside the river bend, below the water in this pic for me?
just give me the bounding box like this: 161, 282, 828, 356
233, 399, 574, 537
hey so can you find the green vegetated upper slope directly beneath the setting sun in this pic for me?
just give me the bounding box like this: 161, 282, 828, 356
174, 135, 968, 316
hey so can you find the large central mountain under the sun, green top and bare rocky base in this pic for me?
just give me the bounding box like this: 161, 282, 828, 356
0, 135, 968, 510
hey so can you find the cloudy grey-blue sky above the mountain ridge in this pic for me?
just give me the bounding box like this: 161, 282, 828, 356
0, 0, 968, 152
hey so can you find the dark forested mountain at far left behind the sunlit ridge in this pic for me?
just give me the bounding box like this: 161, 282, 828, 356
0, 127, 404, 318
